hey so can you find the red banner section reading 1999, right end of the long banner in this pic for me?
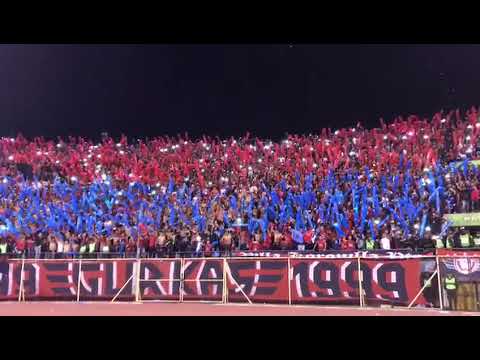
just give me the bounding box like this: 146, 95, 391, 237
291, 259, 425, 304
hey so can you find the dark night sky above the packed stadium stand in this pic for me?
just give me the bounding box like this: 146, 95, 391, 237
0, 44, 480, 139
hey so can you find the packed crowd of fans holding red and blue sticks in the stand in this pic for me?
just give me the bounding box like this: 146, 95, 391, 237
0, 108, 480, 257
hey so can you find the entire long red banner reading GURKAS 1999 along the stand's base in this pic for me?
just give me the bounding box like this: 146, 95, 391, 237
0, 258, 433, 304
